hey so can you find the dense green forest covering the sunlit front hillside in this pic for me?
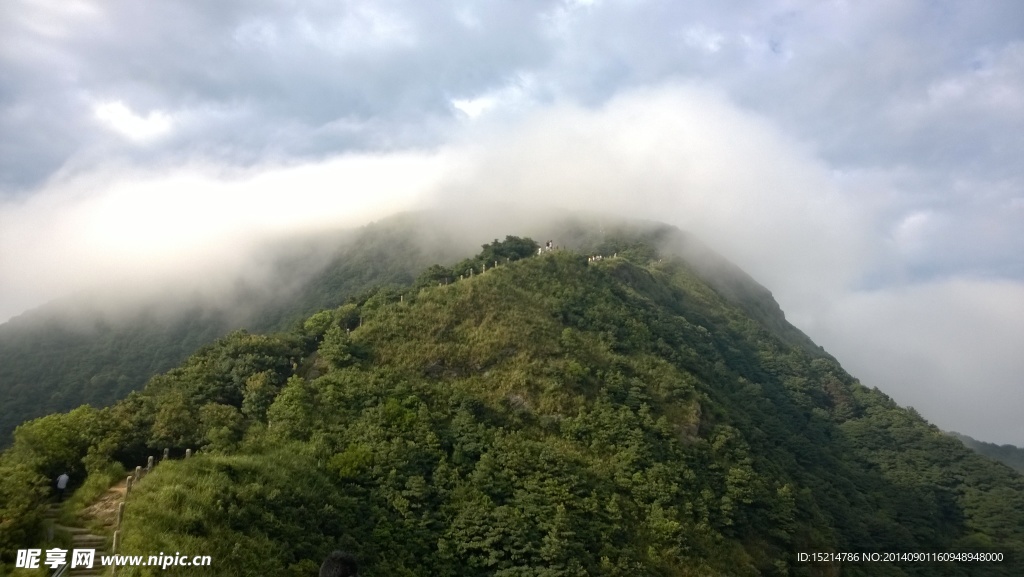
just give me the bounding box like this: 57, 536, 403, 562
0, 231, 1024, 577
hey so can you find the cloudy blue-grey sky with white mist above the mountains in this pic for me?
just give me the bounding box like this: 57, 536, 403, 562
0, 0, 1024, 446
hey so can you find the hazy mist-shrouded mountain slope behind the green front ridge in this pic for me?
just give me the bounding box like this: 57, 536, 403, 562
0, 213, 816, 448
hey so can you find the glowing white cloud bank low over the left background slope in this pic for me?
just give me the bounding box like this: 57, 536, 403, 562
0, 153, 445, 319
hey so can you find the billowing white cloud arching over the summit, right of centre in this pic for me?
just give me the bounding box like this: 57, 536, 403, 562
436, 85, 870, 304
